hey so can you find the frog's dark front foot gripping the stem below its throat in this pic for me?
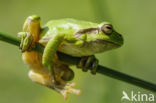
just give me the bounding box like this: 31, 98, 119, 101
77, 55, 99, 74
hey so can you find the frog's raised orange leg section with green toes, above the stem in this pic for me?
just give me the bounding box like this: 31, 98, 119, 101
18, 15, 41, 52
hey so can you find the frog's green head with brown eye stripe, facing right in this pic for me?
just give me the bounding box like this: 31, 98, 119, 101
76, 22, 123, 53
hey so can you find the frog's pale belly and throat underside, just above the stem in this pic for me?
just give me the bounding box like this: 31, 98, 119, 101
58, 42, 114, 57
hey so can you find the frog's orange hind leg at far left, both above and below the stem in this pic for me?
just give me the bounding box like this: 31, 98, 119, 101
18, 15, 47, 71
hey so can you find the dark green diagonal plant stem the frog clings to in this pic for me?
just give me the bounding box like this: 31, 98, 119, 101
0, 33, 156, 92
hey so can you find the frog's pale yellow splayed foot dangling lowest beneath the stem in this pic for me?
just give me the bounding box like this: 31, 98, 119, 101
52, 83, 81, 100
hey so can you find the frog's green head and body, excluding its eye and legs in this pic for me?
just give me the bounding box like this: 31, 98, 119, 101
39, 19, 123, 57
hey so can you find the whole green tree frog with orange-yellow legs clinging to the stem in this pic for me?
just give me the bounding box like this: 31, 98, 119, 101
18, 15, 123, 99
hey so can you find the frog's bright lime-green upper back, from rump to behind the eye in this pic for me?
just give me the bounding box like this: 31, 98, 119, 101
40, 18, 97, 39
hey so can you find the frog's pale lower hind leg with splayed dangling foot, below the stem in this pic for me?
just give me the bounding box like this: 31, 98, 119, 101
29, 70, 81, 99
